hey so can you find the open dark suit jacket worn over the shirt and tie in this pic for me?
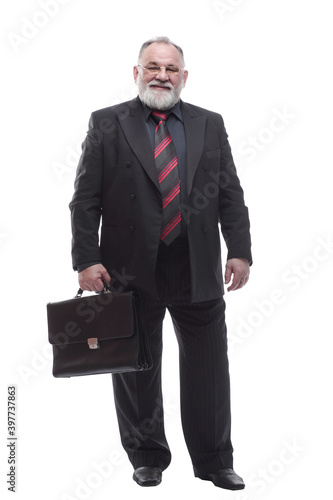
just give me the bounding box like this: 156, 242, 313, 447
70, 98, 252, 302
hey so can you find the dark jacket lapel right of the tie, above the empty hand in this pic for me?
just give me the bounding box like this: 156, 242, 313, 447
181, 101, 206, 196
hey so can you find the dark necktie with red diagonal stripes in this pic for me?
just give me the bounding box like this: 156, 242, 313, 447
152, 111, 181, 245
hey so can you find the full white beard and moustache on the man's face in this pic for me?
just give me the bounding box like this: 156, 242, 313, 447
137, 74, 184, 111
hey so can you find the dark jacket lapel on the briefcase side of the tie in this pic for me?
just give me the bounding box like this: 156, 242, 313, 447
118, 97, 160, 192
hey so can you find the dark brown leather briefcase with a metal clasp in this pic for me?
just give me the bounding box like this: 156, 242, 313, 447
47, 288, 152, 377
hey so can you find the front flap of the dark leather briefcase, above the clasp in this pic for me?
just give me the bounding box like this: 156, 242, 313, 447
47, 292, 134, 345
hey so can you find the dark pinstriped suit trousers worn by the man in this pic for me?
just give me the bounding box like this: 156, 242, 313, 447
112, 238, 233, 475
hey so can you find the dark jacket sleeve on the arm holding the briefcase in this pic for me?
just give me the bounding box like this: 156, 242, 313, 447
69, 114, 103, 270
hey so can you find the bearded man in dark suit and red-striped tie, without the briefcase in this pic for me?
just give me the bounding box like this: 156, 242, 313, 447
70, 37, 252, 490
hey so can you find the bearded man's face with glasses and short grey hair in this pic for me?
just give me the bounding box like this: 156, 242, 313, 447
133, 43, 188, 110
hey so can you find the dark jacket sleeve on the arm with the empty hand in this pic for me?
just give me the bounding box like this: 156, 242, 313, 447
219, 120, 252, 265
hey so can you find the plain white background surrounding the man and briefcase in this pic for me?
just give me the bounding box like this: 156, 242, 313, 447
0, 0, 333, 500
